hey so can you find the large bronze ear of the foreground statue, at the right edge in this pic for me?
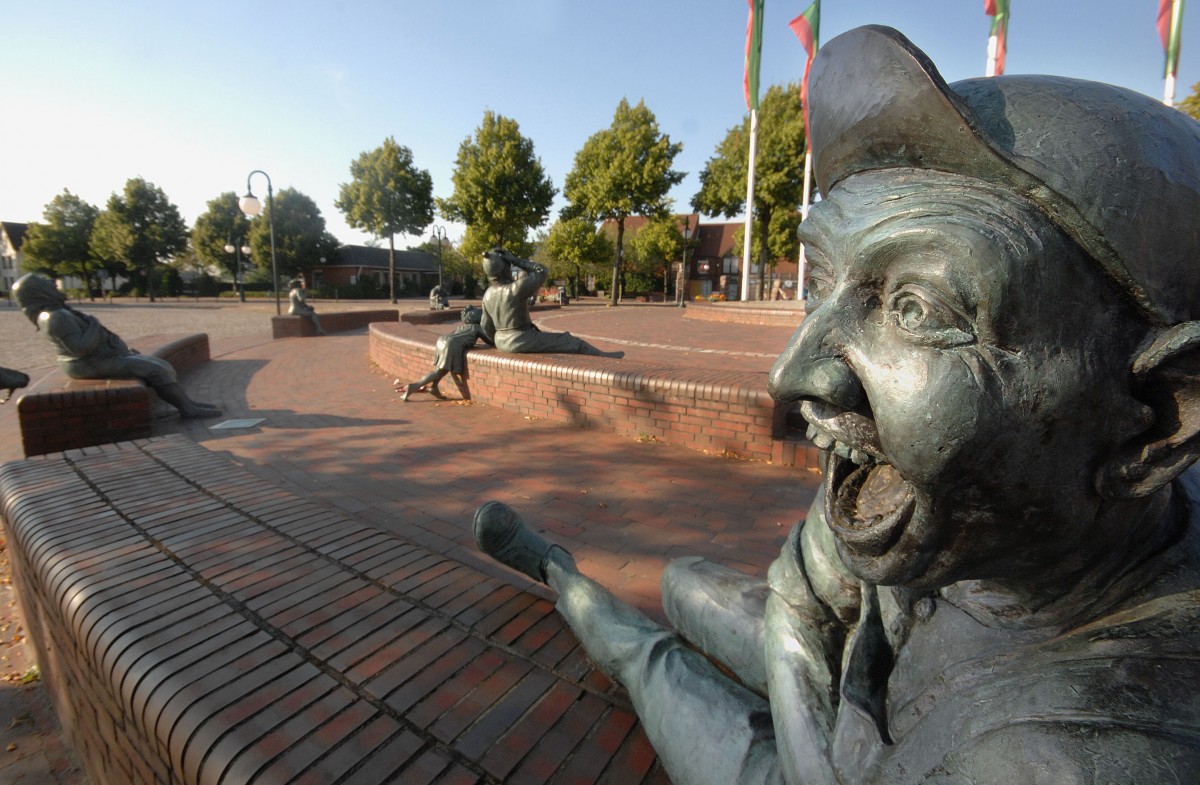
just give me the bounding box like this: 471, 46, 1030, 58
1098, 322, 1200, 498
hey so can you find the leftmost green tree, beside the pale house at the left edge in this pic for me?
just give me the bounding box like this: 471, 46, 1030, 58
22, 188, 100, 293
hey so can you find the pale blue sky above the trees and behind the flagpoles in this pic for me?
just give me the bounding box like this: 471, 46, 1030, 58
0, 0, 1200, 246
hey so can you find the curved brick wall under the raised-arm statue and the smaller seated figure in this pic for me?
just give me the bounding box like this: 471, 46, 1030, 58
370, 324, 817, 467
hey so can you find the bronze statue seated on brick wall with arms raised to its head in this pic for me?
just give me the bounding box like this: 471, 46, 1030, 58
482, 248, 625, 359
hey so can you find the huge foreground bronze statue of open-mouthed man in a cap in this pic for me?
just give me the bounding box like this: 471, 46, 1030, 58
475, 26, 1200, 785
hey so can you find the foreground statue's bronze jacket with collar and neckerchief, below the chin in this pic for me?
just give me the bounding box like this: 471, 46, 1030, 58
764, 471, 1200, 785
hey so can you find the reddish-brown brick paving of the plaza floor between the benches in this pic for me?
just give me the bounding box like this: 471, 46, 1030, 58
0, 301, 817, 783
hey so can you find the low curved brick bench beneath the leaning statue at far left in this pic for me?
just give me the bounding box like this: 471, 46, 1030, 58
17, 332, 210, 455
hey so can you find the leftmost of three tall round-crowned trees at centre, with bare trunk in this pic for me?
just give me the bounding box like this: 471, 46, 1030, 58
334, 137, 433, 302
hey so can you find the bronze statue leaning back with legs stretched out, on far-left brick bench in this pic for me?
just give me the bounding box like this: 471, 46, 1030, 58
12, 272, 221, 418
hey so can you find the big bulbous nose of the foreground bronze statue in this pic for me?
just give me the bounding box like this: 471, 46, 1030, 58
767, 311, 866, 409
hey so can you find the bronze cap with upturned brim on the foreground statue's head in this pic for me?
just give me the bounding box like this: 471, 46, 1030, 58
809, 26, 1200, 323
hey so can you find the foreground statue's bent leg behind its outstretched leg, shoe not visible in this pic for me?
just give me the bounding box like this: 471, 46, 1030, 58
662, 557, 770, 695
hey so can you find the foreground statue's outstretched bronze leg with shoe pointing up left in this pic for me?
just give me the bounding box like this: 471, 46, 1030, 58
475, 502, 784, 785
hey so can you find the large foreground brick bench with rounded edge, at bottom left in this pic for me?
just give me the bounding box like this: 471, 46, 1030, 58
0, 436, 666, 785
